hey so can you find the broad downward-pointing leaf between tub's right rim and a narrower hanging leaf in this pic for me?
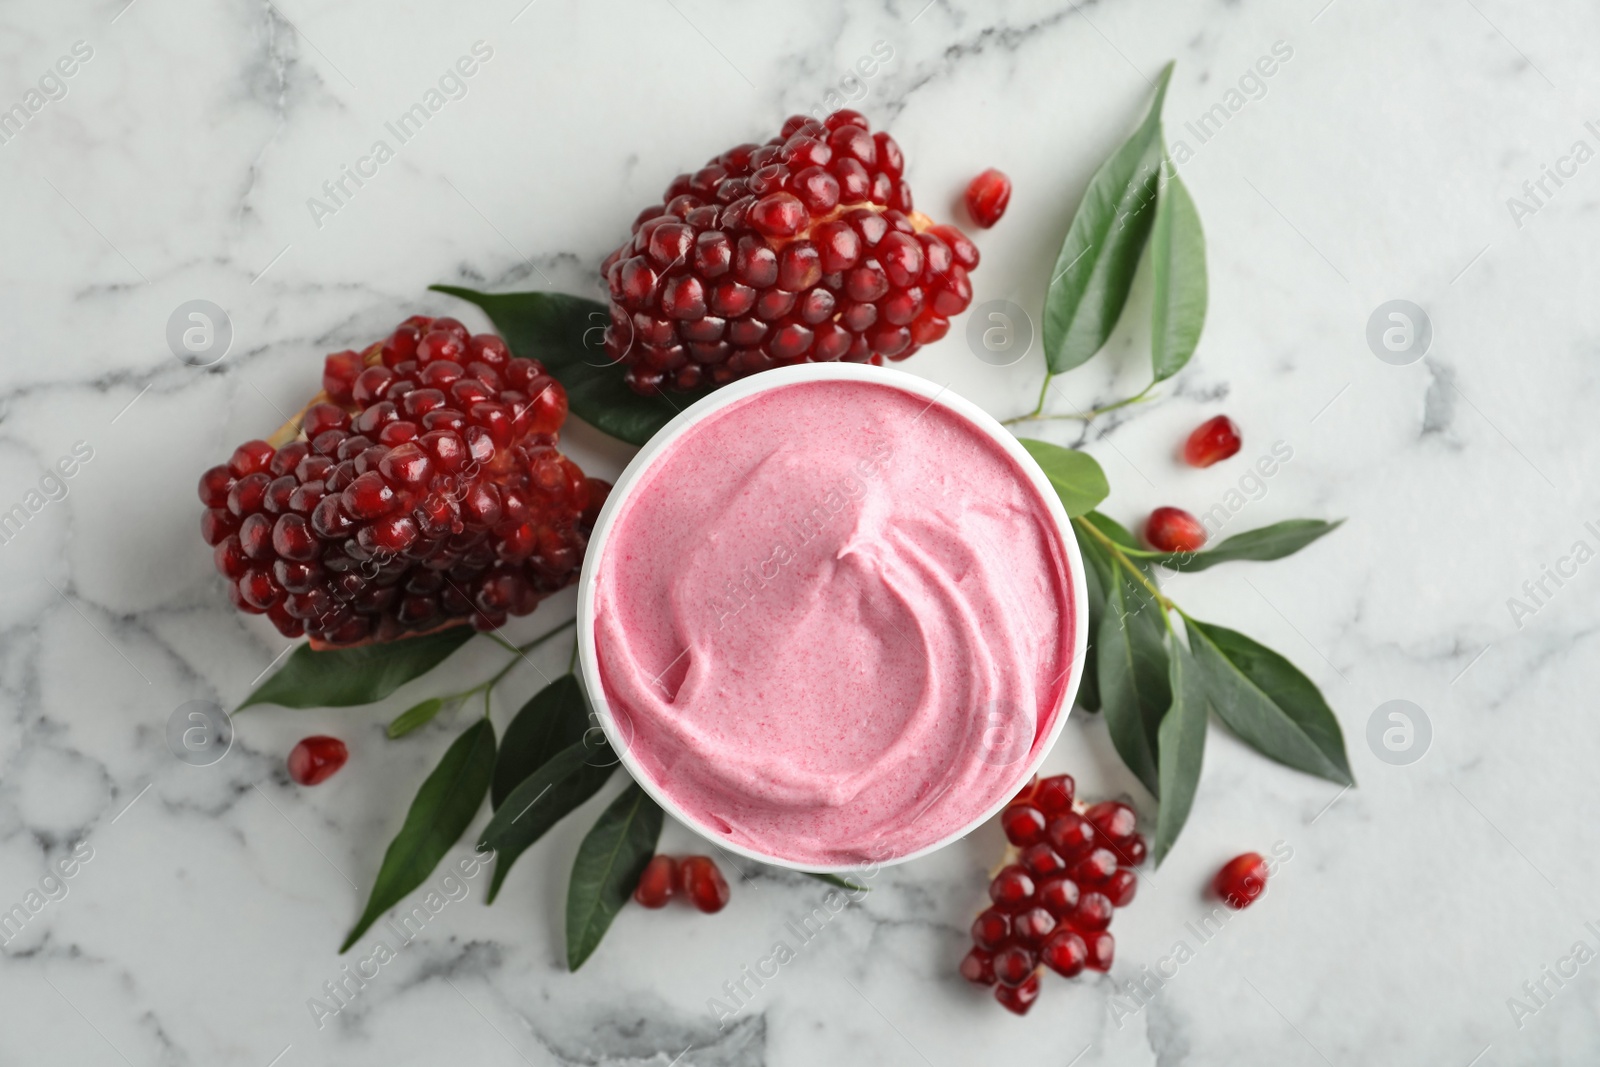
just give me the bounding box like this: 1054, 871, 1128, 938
1096, 566, 1173, 797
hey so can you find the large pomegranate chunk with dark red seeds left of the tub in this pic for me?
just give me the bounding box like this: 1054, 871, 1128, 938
200, 317, 610, 646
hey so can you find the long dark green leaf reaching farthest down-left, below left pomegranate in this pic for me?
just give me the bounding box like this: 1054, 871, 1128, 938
339, 718, 494, 953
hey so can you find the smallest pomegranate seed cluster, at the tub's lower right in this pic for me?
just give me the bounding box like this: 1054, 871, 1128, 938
960, 774, 1149, 1014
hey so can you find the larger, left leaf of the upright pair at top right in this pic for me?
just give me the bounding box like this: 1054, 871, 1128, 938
1043, 62, 1173, 374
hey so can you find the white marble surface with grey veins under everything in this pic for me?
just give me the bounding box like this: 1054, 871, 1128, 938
0, 0, 1600, 1067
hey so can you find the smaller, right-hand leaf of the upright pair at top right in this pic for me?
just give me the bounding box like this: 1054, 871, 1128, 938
1150, 152, 1206, 382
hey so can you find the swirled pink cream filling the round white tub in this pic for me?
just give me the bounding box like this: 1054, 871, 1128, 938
592, 379, 1078, 869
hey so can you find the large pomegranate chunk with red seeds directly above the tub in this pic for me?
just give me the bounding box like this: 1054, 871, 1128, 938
602, 110, 978, 395
